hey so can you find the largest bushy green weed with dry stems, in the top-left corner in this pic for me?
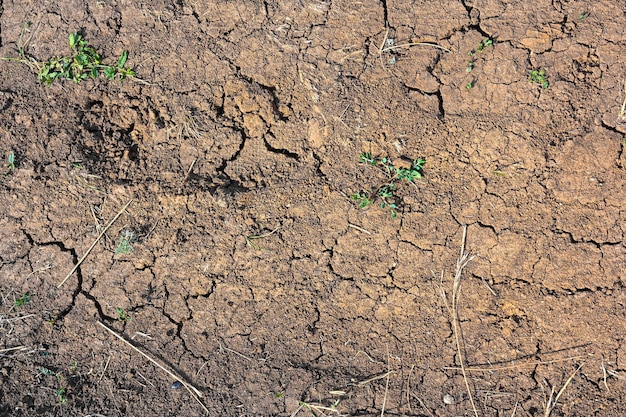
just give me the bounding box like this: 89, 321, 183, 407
2, 26, 135, 86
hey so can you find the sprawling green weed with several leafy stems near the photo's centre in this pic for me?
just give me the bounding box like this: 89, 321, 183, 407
350, 152, 426, 217
